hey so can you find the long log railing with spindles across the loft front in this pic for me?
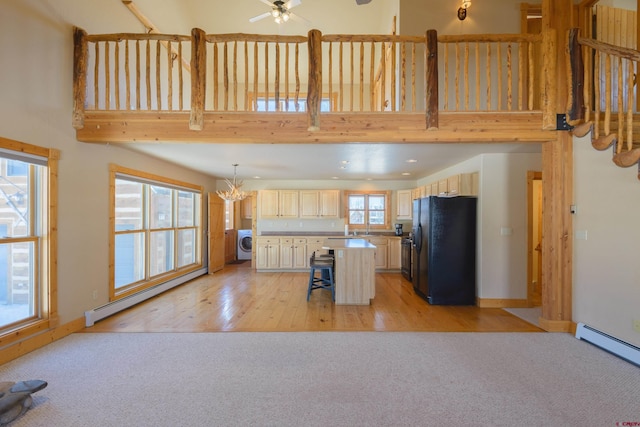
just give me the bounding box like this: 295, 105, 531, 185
73, 29, 542, 130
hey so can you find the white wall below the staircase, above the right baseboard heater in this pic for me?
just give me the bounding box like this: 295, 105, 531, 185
573, 135, 640, 346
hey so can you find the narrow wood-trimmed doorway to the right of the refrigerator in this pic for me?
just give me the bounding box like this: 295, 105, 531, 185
527, 171, 543, 307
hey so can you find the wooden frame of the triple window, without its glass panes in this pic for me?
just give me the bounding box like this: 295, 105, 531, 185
109, 164, 205, 301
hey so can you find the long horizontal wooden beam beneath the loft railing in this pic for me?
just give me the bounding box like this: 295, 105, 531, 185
76, 111, 556, 144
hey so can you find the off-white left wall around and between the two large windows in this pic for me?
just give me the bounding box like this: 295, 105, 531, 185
0, 0, 215, 323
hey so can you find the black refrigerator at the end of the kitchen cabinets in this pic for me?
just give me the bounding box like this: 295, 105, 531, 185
412, 196, 477, 305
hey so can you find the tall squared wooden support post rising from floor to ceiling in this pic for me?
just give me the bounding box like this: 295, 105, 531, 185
539, 0, 574, 332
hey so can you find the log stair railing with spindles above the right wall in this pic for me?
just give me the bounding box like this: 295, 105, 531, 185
568, 29, 640, 174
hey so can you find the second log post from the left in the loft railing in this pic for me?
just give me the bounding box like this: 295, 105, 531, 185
189, 28, 207, 130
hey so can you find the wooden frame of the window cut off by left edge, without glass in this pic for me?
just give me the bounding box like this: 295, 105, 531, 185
0, 137, 60, 346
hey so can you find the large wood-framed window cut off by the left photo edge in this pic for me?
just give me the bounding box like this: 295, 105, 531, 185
0, 138, 58, 342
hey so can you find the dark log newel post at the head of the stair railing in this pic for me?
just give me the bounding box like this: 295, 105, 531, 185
567, 28, 584, 126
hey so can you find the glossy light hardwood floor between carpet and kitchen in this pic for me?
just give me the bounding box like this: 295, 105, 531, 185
85, 262, 542, 332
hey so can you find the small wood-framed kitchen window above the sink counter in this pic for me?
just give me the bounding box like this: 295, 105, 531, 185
345, 191, 391, 231
